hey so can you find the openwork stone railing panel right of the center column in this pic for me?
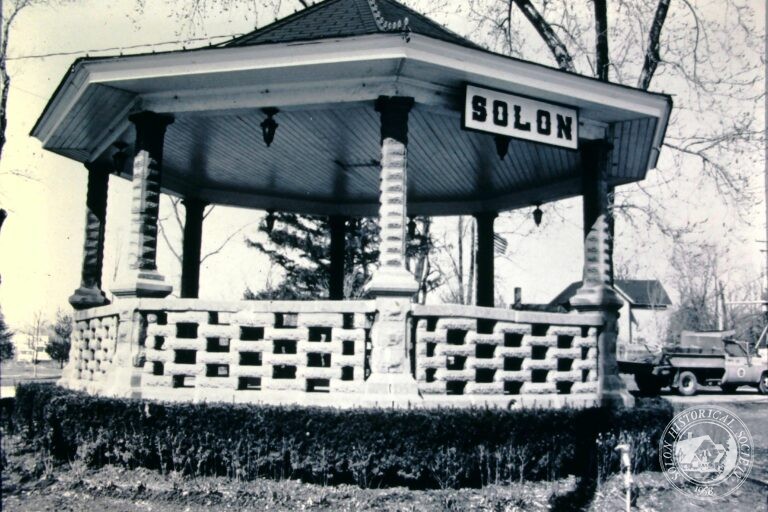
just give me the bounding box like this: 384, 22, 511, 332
414, 306, 597, 395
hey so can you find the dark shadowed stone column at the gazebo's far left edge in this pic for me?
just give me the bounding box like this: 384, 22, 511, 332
69, 164, 109, 309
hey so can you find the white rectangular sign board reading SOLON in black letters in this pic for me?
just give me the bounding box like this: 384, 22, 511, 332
464, 85, 579, 149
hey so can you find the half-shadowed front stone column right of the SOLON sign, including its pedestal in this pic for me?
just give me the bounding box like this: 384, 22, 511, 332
571, 141, 634, 407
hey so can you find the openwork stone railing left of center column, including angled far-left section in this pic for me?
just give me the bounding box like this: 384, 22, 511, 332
61, 299, 374, 404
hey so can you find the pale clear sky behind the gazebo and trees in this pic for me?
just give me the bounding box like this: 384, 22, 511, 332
0, 0, 766, 329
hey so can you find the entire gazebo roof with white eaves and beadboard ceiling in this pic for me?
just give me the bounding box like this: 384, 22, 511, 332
32, 0, 671, 215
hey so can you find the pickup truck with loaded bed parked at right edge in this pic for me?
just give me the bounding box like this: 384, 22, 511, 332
618, 327, 768, 396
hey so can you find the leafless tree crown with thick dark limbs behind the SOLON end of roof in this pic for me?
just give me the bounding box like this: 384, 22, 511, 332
459, 0, 765, 236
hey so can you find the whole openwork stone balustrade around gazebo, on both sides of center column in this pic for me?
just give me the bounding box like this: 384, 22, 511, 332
62, 298, 601, 407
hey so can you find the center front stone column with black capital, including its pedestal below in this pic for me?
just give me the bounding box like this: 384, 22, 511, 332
366, 96, 419, 402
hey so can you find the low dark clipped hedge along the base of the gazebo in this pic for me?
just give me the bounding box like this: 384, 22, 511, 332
7, 384, 673, 488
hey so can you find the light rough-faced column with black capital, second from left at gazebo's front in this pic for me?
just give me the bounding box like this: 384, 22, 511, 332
112, 112, 173, 297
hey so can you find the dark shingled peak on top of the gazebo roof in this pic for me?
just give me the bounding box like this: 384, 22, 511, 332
222, 0, 480, 48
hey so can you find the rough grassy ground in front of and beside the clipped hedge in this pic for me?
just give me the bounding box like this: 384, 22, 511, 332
2, 363, 768, 512
